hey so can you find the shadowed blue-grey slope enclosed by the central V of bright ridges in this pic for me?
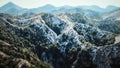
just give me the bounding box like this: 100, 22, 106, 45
42, 14, 67, 35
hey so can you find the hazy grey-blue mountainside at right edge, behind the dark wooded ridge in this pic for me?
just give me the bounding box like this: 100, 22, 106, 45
96, 9, 120, 34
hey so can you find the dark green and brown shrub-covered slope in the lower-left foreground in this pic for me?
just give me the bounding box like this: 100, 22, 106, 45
0, 17, 50, 68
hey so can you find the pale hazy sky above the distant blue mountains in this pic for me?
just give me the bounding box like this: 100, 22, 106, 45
0, 0, 120, 8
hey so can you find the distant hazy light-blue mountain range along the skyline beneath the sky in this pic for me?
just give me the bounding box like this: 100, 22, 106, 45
0, 2, 119, 15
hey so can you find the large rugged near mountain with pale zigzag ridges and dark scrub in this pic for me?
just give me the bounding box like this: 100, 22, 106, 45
0, 13, 120, 68
